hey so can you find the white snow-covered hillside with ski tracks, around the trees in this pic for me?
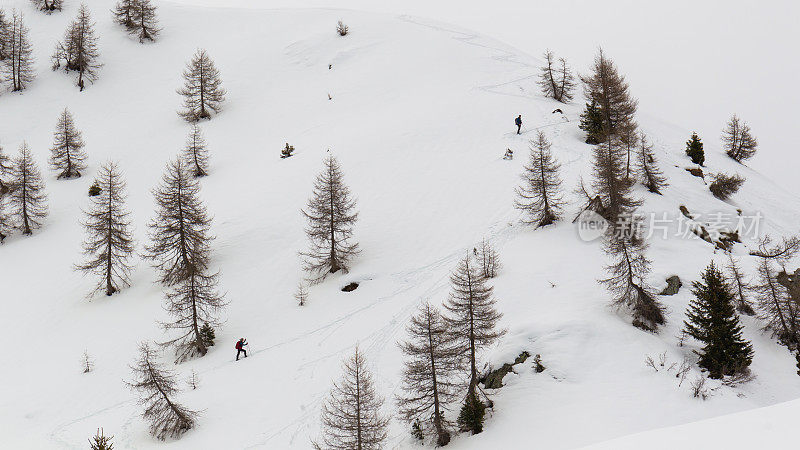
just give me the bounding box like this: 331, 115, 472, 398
0, 0, 800, 450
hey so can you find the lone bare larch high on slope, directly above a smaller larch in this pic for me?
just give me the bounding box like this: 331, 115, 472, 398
178, 49, 225, 122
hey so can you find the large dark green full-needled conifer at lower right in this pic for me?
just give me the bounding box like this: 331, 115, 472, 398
684, 262, 753, 379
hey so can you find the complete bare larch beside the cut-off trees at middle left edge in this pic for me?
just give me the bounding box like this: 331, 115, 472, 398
9, 142, 47, 235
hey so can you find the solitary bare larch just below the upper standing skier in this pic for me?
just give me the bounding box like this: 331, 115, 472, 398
515, 131, 564, 228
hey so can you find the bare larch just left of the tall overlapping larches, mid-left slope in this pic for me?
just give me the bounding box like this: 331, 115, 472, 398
76, 162, 135, 295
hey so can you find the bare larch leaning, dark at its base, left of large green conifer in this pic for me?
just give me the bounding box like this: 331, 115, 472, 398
600, 223, 666, 332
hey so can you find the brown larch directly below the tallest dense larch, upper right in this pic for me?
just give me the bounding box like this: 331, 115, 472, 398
592, 136, 641, 223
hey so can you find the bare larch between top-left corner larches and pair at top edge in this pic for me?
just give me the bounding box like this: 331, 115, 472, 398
53, 4, 102, 91
